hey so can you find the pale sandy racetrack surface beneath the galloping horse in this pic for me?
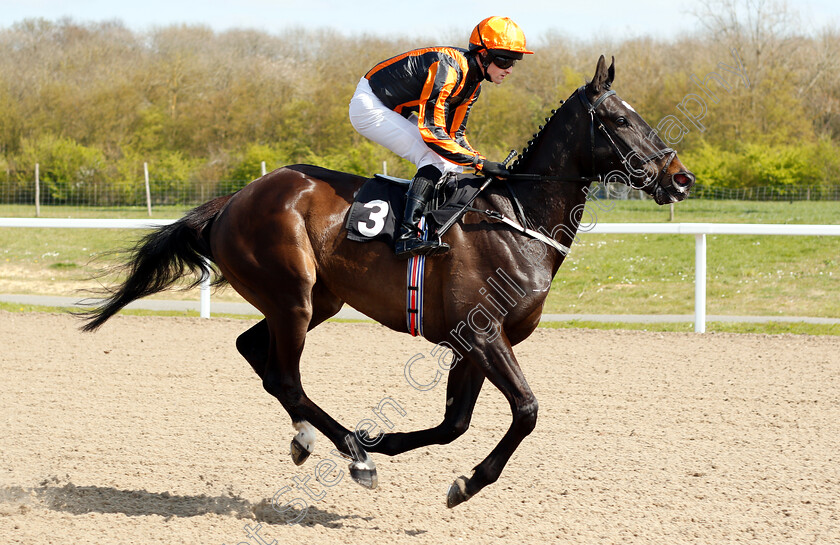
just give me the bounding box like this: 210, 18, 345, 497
0, 312, 840, 545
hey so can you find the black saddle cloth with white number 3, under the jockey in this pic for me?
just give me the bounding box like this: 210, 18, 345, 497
344, 174, 485, 245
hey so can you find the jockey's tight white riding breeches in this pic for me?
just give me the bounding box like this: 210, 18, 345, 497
350, 78, 463, 174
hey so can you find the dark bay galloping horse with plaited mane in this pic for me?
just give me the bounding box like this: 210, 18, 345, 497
84, 56, 694, 507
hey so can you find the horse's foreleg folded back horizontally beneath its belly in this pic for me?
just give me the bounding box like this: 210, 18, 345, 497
359, 361, 484, 456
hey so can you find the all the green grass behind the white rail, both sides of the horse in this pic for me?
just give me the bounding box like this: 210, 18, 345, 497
0, 200, 840, 331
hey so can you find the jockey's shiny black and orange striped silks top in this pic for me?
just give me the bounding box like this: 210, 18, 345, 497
365, 47, 484, 166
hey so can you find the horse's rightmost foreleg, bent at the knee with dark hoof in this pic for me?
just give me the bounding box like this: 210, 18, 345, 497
446, 334, 537, 507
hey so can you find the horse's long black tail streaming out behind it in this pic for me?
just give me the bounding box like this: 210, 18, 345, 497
79, 195, 233, 331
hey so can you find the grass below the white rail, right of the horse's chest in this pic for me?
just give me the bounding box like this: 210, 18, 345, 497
546, 235, 840, 317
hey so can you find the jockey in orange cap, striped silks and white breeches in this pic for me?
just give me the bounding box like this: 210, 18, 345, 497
350, 17, 533, 257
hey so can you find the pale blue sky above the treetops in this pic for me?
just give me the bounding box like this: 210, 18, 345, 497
0, 0, 840, 45
